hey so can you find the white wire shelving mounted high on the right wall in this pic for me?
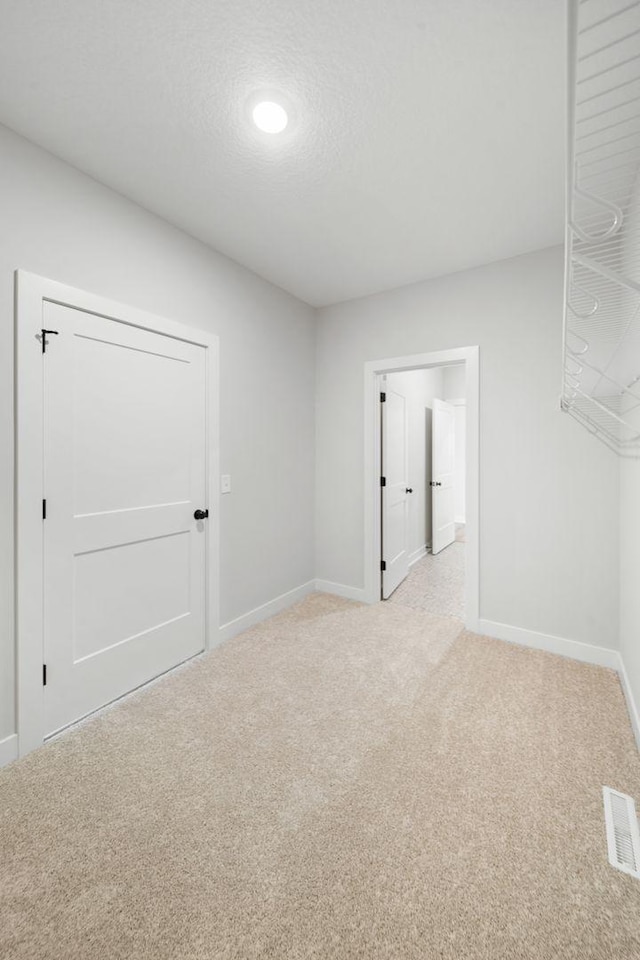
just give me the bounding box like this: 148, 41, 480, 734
561, 0, 640, 457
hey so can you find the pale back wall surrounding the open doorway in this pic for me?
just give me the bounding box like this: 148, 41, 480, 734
316, 247, 618, 647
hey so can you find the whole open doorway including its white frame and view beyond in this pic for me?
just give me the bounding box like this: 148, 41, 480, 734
365, 347, 479, 630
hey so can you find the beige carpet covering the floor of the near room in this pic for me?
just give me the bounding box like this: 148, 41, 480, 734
0, 596, 640, 960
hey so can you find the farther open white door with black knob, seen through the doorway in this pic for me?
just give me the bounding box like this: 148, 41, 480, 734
431, 400, 456, 553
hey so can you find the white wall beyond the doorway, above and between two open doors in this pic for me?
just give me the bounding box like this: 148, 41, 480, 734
386, 368, 442, 561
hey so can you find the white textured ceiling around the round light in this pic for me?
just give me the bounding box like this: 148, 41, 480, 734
0, 0, 565, 305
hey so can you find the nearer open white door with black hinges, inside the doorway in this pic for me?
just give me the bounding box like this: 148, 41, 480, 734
382, 389, 409, 600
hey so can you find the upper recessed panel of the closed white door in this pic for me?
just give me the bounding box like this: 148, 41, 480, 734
71, 336, 192, 514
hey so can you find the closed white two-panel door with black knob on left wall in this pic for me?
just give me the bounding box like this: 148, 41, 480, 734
43, 303, 209, 735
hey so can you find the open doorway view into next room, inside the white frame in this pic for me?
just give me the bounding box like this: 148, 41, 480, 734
380, 363, 466, 620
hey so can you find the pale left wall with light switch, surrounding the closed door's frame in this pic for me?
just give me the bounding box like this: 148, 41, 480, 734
0, 127, 315, 740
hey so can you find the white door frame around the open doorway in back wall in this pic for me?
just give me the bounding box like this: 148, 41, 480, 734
364, 346, 480, 632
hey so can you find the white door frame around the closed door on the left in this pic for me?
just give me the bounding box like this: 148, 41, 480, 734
14, 270, 220, 756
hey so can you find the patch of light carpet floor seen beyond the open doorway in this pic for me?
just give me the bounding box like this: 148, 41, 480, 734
389, 540, 465, 620
